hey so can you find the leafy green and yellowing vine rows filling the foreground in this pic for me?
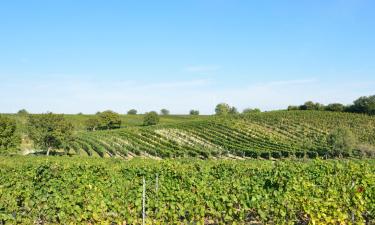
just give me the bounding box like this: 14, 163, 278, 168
0, 157, 375, 224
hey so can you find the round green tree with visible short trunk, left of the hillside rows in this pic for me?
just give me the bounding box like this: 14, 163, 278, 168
28, 113, 73, 155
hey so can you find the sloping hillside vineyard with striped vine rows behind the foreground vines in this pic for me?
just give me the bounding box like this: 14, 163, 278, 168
64, 111, 375, 158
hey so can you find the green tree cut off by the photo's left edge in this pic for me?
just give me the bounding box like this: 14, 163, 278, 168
0, 115, 21, 154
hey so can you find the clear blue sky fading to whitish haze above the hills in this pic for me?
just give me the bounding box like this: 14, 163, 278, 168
0, 0, 375, 114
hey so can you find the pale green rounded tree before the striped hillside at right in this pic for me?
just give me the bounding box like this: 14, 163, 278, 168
328, 127, 356, 157
